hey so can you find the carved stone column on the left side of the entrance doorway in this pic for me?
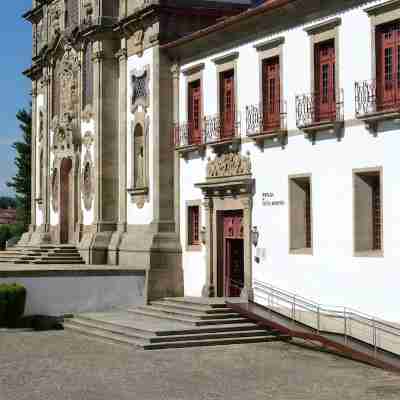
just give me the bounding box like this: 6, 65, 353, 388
202, 197, 215, 297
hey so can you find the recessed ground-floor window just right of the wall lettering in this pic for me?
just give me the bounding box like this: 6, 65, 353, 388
289, 176, 312, 253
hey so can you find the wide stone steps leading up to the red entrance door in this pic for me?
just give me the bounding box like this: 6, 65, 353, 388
64, 298, 288, 350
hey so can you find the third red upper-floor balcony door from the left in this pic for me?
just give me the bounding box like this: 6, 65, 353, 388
262, 57, 281, 132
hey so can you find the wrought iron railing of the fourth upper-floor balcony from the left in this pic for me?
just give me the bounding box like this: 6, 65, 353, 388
296, 89, 344, 128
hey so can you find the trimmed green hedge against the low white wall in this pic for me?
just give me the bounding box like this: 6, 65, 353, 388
0, 283, 26, 328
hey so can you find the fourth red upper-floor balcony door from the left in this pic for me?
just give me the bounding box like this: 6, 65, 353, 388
315, 40, 336, 122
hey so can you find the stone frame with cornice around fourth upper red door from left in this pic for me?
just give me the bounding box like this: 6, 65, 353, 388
304, 18, 342, 100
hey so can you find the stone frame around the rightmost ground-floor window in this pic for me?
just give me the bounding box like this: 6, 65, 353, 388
352, 166, 384, 257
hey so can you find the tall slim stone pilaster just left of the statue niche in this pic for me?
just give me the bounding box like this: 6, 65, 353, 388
116, 38, 128, 232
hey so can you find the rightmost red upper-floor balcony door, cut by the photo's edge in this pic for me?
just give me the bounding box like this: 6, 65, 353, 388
376, 22, 400, 110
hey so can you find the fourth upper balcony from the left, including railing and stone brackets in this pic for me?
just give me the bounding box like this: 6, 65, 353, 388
296, 89, 344, 143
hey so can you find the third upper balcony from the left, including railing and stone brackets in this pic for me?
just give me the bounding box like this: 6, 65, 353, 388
246, 100, 287, 148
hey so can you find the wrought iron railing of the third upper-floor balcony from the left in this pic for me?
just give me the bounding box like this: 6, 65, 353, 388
246, 100, 287, 137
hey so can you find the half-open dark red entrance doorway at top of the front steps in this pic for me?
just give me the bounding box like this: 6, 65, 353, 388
217, 210, 244, 297
